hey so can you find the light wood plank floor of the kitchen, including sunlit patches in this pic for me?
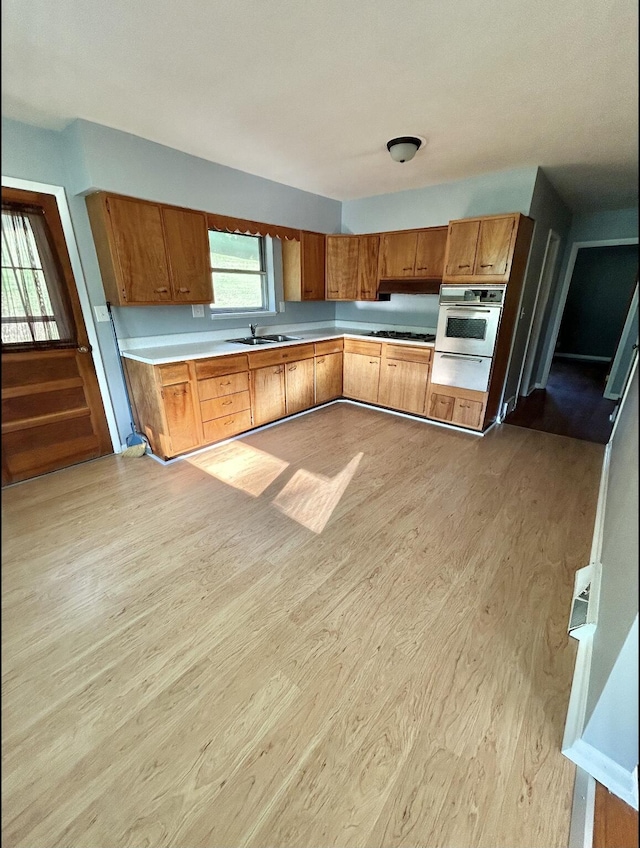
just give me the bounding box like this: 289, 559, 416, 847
2, 404, 603, 848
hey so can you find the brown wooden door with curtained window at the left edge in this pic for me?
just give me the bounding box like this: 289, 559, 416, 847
2, 185, 112, 486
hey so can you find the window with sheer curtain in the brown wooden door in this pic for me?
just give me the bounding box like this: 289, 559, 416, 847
2, 202, 76, 347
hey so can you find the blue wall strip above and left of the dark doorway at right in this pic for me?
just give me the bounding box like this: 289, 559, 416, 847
533, 206, 638, 382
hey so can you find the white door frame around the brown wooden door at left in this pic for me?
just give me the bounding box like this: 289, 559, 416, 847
1, 175, 122, 453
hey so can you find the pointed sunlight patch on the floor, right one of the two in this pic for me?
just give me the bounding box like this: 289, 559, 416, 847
272, 453, 364, 533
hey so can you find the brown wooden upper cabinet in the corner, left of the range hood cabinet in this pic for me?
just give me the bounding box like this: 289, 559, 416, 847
326, 235, 380, 300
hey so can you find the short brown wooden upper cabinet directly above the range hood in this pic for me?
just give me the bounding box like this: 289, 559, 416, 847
378, 227, 447, 279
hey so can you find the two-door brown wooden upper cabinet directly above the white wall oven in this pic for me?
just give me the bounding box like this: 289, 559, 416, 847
444, 213, 522, 283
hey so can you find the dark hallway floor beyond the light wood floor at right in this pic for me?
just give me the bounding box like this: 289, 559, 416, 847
505, 358, 616, 445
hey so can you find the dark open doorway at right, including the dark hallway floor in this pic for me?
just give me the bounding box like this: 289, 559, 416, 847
505, 241, 638, 444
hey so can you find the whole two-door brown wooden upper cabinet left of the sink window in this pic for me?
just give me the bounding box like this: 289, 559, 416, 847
86, 192, 213, 306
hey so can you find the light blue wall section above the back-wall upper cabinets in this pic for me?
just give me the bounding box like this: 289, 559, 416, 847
342, 166, 538, 233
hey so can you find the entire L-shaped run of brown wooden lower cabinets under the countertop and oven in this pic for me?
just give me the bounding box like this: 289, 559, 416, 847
123, 339, 487, 459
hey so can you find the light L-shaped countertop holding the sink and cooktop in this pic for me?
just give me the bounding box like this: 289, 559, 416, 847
122, 326, 433, 365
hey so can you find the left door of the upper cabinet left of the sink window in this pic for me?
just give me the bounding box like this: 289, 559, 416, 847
107, 197, 171, 303
